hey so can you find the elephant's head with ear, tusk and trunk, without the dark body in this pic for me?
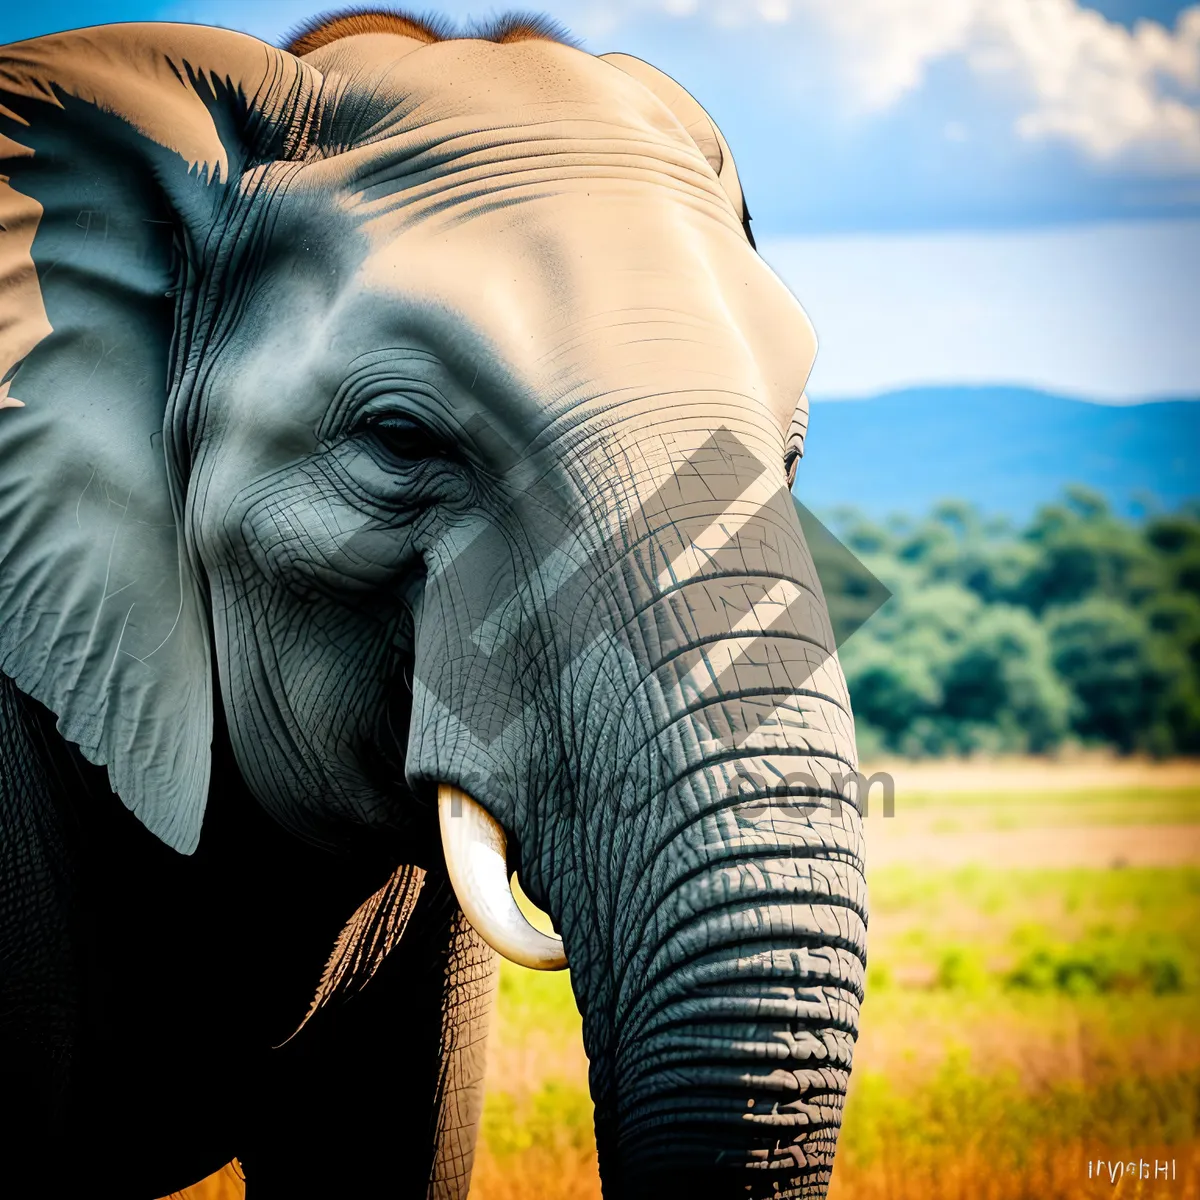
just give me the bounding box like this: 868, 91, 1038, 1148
0, 17, 865, 1196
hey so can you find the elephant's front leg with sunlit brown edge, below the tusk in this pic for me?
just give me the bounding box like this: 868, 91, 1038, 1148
239, 870, 497, 1200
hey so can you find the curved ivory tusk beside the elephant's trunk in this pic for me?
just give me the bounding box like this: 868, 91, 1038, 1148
438, 784, 566, 971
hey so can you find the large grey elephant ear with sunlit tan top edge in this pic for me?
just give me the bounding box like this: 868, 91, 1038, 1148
0, 24, 313, 853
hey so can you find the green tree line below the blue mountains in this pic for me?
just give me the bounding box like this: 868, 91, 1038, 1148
832, 487, 1200, 757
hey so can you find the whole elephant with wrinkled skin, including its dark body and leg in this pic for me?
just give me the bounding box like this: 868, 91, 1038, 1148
0, 10, 868, 1200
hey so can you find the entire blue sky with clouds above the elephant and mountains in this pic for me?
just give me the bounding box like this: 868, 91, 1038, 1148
0, 0, 1200, 402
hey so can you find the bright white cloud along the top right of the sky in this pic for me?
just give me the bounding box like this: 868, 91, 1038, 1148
652, 0, 1200, 172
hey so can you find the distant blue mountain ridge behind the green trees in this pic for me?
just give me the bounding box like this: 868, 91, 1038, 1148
796, 388, 1200, 518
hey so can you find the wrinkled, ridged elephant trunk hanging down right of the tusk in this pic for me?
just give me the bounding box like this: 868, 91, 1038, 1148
529, 460, 866, 1200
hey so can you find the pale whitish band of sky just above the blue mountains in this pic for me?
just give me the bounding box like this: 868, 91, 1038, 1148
762, 217, 1200, 398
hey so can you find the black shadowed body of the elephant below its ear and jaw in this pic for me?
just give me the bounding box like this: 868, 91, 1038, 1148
0, 680, 494, 1198
